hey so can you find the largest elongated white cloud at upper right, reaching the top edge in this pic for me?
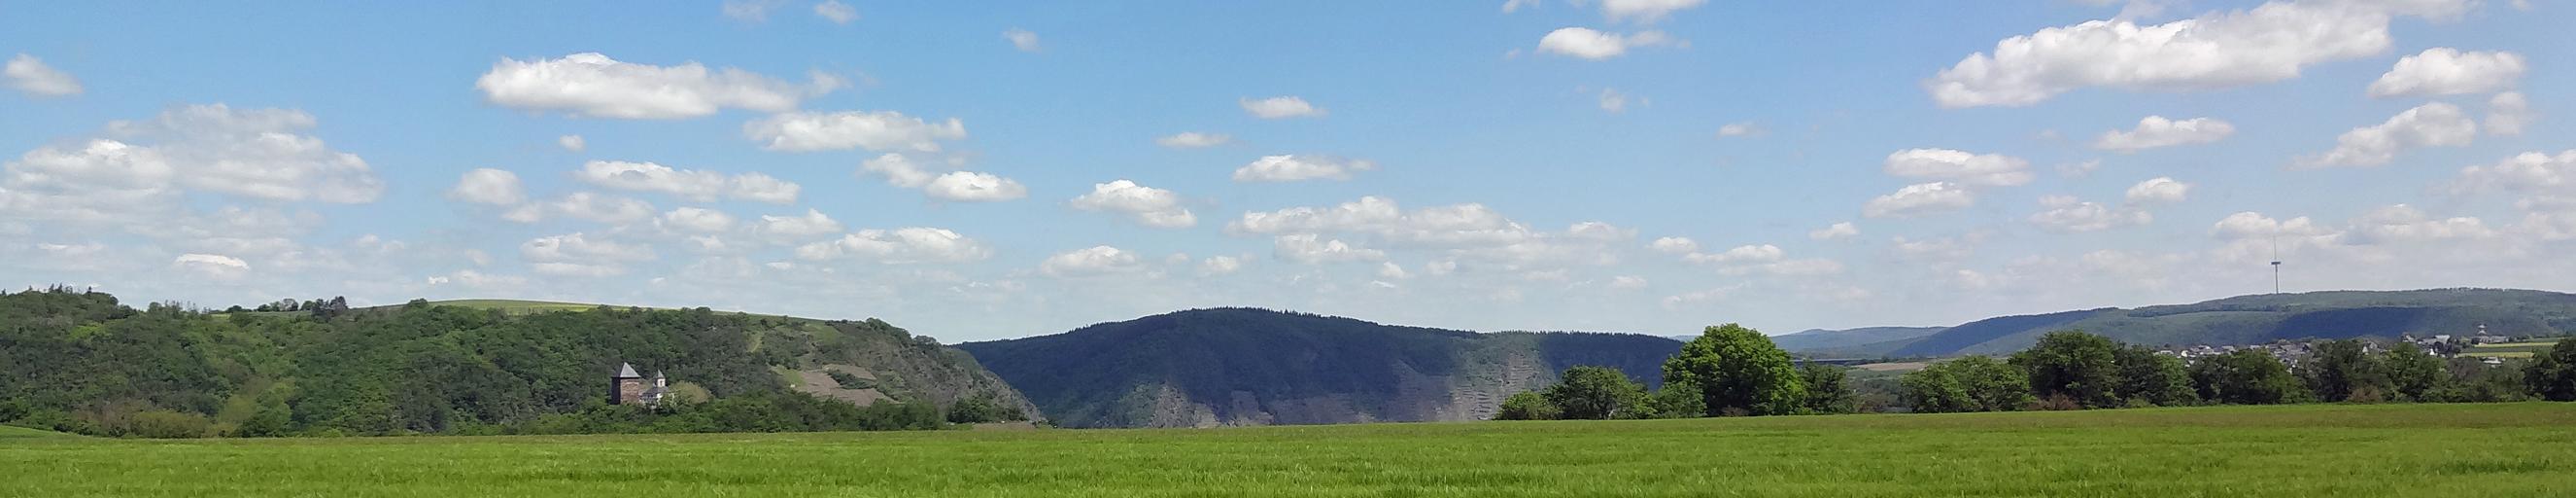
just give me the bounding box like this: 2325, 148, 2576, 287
1924, 0, 2468, 108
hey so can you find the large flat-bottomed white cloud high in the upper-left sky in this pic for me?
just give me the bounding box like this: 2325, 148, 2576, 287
474, 52, 838, 119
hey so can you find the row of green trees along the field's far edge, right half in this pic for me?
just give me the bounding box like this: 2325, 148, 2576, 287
1494, 325, 2576, 420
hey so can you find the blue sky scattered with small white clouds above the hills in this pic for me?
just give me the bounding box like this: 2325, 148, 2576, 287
0, 0, 2576, 340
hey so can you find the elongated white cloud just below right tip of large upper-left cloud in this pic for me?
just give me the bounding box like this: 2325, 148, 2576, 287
741, 111, 966, 153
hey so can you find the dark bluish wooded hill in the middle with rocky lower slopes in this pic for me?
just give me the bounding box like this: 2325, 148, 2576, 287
958, 307, 1682, 426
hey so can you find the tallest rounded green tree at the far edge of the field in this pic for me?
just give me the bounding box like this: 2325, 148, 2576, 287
1665, 323, 1805, 415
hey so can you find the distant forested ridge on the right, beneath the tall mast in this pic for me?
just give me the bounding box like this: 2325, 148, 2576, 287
1865, 289, 2576, 356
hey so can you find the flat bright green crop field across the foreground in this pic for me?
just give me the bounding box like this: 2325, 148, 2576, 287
0, 403, 2576, 498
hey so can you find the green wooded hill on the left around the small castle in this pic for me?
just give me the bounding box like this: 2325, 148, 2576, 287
0, 289, 1033, 436
